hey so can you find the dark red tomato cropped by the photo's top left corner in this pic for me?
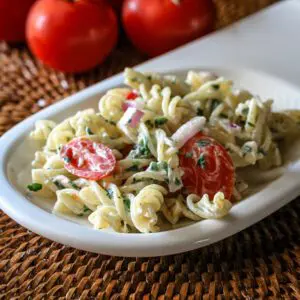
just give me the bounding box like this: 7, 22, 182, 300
0, 0, 35, 42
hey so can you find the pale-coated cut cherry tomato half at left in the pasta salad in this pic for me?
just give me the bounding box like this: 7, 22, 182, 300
60, 138, 116, 180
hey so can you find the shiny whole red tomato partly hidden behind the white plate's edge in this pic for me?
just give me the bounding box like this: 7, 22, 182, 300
122, 0, 214, 56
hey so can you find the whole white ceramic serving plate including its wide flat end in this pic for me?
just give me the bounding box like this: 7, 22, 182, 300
0, 1, 300, 256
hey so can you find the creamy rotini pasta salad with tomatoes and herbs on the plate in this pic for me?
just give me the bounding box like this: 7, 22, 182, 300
27, 68, 300, 233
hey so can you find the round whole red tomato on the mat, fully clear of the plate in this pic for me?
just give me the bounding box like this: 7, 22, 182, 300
26, 0, 118, 72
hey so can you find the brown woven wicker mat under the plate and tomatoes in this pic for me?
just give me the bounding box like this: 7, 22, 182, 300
0, 0, 300, 299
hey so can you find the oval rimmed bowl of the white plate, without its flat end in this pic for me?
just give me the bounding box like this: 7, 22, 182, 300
0, 67, 300, 256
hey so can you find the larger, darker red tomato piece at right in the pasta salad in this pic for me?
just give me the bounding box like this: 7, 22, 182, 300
179, 133, 234, 200
